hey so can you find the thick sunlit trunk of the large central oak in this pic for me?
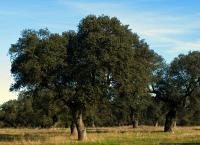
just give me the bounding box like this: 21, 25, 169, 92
74, 110, 86, 141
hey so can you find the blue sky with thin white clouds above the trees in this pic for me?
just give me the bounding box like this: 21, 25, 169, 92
0, 0, 200, 104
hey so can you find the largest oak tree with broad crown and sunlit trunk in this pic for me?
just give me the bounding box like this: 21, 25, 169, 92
9, 15, 167, 140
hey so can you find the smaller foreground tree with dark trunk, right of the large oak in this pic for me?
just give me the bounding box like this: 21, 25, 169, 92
153, 51, 200, 132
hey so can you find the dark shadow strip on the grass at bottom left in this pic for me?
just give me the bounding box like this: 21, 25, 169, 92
0, 134, 45, 142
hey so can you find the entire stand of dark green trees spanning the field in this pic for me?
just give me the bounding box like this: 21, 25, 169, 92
0, 15, 200, 140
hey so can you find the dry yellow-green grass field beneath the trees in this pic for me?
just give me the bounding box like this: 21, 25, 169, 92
0, 126, 200, 145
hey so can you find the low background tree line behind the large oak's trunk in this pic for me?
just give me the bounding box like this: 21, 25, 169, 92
0, 92, 200, 128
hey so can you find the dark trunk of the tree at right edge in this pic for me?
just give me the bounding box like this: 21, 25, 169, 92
164, 109, 176, 132
